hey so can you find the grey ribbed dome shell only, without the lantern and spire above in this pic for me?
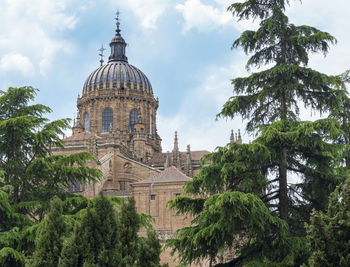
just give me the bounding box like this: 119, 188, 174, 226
83, 60, 153, 94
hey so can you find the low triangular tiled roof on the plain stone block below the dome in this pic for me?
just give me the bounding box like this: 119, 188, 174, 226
133, 166, 191, 185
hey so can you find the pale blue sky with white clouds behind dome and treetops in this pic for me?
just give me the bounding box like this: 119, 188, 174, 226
0, 0, 350, 151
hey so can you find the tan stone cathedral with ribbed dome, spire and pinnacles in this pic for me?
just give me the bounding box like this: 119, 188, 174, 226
53, 15, 240, 266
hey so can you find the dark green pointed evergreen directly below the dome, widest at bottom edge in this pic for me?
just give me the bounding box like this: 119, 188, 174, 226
59, 194, 121, 267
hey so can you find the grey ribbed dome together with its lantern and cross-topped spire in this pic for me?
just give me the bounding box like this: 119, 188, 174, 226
83, 14, 153, 96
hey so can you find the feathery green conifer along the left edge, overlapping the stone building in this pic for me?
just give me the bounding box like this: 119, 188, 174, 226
0, 86, 101, 266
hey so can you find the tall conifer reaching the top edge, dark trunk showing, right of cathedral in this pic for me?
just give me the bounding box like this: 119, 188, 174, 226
218, 0, 349, 222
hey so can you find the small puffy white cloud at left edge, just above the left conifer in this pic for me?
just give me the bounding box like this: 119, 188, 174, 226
0, 53, 34, 76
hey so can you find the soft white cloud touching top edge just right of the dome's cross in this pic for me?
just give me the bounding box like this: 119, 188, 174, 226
119, 0, 170, 30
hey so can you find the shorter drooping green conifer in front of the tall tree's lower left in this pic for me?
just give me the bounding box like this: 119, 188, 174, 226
167, 142, 307, 266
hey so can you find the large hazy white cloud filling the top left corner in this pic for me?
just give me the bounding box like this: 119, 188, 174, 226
0, 0, 77, 75
